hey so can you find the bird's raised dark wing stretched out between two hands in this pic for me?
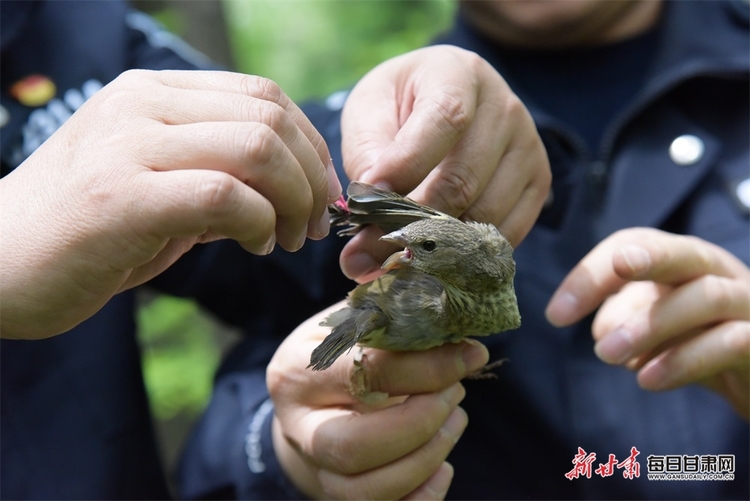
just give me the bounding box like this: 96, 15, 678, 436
328, 181, 451, 235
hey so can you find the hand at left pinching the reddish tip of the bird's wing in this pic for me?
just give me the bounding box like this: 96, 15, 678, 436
0, 71, 341, 338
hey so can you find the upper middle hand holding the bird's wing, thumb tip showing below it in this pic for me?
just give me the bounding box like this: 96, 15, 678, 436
341, 46, 551, 282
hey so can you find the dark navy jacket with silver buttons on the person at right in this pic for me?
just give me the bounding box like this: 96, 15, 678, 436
181, 2, 750, 499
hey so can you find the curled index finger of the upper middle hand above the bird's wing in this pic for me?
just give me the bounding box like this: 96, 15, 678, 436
342, 47, 478, 193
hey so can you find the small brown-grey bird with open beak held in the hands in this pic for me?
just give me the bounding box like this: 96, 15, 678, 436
308, 182, 521, 370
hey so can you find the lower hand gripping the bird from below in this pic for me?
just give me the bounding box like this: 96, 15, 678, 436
266, 303, 488, 499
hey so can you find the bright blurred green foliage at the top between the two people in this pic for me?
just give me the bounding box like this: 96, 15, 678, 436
225, 0, 455, 102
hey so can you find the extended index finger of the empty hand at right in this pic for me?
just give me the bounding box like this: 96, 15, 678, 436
546, 228, 744, 326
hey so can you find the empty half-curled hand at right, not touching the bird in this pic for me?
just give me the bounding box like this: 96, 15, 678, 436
547, 228, 750, 419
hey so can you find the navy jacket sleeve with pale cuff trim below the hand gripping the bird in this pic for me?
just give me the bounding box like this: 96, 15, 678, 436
179, 338, 304, 499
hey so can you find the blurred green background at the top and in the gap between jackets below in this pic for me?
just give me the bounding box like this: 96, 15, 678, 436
132, 0, 456, 480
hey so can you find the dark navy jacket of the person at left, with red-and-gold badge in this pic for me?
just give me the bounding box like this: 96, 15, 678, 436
0, 1, 346, 499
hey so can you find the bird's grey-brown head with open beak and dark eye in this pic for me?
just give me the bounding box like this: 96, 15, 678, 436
381, 217, 515, 287
